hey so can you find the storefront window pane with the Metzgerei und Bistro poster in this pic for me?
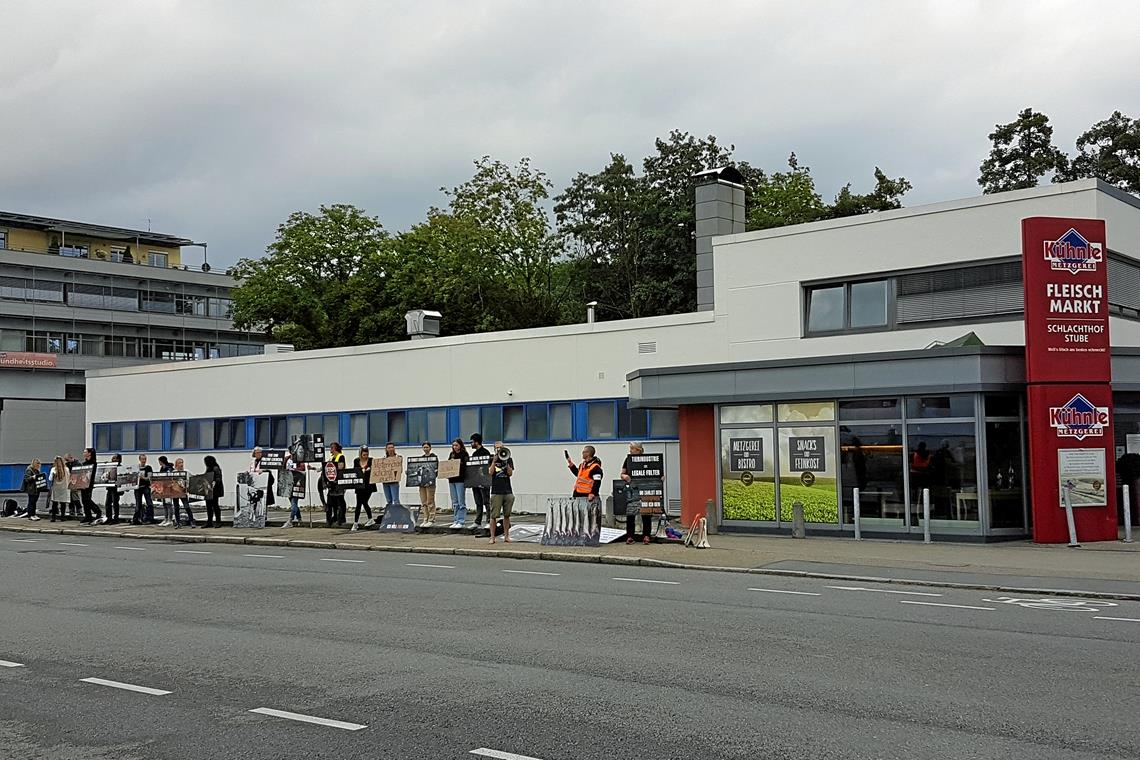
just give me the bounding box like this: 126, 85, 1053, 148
720, 427, 776, 522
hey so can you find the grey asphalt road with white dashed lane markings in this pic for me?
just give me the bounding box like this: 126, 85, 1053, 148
0, 532, 1140, 760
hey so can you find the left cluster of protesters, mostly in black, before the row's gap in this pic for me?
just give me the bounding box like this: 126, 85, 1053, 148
5, 448, 225, 528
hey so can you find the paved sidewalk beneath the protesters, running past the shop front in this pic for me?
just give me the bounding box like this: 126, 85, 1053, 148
0, 513, 1140, 600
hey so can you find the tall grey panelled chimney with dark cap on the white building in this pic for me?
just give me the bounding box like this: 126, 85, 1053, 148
693, 166, 744, 311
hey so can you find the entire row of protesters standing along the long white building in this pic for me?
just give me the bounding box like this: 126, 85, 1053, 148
5, 433, 652, 544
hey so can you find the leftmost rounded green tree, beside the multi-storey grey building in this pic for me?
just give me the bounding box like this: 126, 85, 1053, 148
226, 205, 394, 350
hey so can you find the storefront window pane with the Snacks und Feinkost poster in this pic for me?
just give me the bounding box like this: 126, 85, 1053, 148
780, 421, 839, 523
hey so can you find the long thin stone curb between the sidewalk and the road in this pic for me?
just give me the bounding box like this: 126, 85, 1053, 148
0, 525, 1140, 602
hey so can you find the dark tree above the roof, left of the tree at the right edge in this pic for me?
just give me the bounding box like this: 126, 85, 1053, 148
978, 108, 1068, 193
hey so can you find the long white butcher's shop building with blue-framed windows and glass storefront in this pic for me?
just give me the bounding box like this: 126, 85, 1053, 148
87, 180, 1140, 540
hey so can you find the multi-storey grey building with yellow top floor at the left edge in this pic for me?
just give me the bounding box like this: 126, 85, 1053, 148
0, 212, 262, 490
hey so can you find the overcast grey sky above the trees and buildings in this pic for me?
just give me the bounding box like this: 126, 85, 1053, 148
0, 0, 1140, 265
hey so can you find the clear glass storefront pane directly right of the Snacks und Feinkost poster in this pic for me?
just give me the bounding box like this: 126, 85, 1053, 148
839, 421, 906, 528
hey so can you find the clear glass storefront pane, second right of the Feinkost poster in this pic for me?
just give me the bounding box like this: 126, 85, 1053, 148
906, 421, 978, 525
